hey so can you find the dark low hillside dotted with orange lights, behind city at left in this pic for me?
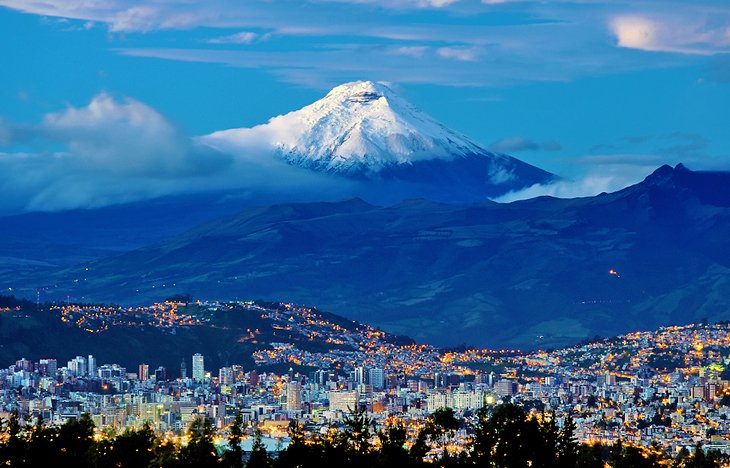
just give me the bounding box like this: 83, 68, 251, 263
0, 296, 411, 372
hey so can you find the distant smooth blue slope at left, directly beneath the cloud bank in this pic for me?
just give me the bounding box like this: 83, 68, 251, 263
0, 193, 320, 276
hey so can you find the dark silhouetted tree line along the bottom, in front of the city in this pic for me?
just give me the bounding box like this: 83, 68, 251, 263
0, 404, 724, 468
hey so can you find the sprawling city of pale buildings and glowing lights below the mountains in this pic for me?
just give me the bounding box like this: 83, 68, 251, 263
0, 302, 730, 453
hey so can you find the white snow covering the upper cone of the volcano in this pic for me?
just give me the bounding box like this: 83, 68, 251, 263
202, 81, 500, 173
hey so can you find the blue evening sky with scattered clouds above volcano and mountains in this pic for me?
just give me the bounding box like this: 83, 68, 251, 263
0, 0, 730, 209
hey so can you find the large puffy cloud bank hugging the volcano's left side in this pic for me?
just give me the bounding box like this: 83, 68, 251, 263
0, 93, 346, 213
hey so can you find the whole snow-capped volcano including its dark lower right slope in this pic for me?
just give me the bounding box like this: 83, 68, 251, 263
201, 81, 553, 200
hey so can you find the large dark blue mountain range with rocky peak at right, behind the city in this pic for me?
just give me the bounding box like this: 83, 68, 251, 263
2, 165, 730, 347
